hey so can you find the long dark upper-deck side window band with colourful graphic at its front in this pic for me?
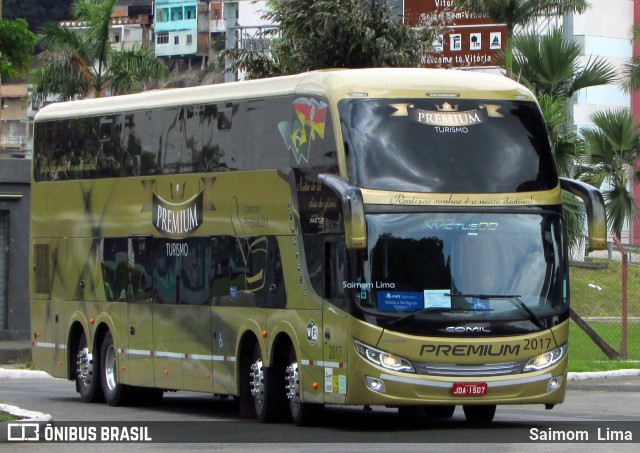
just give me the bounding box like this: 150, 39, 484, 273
34, 96, 338, 180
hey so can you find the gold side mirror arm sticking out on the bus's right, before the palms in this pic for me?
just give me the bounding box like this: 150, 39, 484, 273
560, 178, 607, 251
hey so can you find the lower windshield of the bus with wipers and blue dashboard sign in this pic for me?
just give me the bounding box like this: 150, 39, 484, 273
347, 213, 568, 334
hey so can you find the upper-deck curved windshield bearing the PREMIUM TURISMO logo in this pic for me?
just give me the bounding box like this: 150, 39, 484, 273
339, 99, 558, 193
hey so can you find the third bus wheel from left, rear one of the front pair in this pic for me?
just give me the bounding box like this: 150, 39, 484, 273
249, 342, 278, 423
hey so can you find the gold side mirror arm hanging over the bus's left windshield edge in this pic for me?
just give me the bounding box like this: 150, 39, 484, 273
318, 173, 367, 250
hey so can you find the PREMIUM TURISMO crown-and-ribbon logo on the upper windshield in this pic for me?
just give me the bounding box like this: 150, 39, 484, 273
391, 102, 503, 134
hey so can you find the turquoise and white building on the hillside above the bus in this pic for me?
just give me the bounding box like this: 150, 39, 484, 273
155, 0, 199, 57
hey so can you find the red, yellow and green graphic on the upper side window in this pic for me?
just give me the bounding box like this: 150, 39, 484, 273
278, 98, 327, 164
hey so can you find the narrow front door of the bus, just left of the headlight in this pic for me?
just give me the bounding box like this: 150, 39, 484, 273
320, 235, 348, 403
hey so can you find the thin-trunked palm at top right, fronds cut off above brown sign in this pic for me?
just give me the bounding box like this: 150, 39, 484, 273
455, 0, 589, 75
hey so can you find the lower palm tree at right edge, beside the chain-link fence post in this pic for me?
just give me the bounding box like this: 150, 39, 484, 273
580, 109, 640, 239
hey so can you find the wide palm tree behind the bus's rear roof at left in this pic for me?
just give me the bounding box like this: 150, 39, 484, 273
30, 0, 168, 102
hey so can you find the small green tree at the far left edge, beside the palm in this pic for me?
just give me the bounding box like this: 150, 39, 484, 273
0, 19, 36, 79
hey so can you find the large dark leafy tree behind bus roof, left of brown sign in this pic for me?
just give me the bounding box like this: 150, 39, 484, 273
221, 0, 435, 78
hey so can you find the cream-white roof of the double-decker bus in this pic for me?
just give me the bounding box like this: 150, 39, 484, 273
35, 68, 534, 121
